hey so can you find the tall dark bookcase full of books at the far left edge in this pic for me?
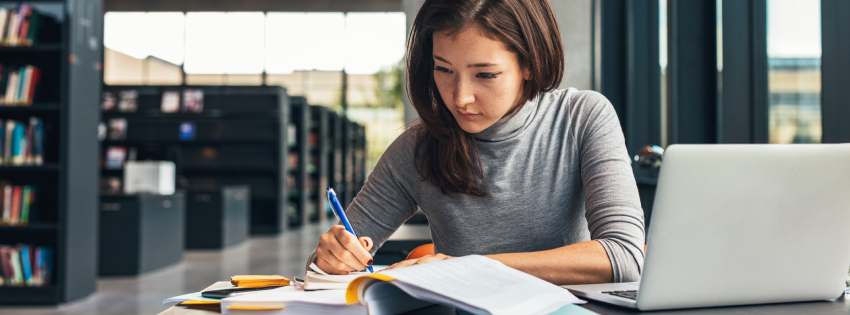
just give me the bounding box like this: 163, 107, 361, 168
0, 0, 102, 305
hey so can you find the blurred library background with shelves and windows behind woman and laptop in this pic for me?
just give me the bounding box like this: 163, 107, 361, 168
0, 0, 850, 314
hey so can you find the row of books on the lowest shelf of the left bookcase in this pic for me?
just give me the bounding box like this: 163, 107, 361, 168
0, 245, 53, 287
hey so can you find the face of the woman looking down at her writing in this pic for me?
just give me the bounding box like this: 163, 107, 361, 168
433, 24, 528, 133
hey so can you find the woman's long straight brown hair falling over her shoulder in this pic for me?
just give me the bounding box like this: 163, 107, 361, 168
407, 0, 564, 196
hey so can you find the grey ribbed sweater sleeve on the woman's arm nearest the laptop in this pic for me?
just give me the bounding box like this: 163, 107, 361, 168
574, 92, 645, 282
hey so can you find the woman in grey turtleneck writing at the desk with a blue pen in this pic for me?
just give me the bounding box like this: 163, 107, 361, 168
314, 0, 644, 284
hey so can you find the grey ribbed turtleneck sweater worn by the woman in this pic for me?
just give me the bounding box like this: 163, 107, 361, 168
338, 89, 644, 282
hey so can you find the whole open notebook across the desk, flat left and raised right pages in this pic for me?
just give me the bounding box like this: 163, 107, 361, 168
221, 255, 587, 315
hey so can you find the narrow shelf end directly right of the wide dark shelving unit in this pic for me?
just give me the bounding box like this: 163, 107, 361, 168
287, 96, 310, 227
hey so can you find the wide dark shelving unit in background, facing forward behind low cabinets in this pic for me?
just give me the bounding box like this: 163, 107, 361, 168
101, 86, 289, 234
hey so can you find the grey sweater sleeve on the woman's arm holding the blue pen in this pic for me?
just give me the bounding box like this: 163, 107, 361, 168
307, 129, 418, 269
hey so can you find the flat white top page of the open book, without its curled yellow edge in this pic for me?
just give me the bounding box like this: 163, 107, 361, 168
381, 255, 584, 314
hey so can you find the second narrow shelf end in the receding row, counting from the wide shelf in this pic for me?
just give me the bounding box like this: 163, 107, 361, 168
307, 105, 332, 227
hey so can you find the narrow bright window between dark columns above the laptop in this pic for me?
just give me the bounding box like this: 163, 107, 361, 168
767, 0, 822, 143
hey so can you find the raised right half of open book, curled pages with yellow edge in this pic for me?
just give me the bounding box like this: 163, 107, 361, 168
346, 255, 584, 315
